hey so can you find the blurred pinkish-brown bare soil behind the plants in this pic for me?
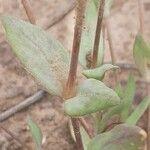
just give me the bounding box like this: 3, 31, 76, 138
0, 0, 150, 150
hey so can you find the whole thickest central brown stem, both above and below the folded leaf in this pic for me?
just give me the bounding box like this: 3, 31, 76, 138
64, 0, 86, 150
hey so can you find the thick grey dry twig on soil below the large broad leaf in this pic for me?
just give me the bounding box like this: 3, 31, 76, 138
0, 90, 45, 122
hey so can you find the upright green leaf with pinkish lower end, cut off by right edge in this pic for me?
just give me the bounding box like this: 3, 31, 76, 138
133, 35, 150, 81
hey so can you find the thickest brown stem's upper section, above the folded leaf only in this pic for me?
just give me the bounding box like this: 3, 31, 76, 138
64, 0, 86, 98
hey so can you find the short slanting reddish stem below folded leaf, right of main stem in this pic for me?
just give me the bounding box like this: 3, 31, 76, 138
79, 118, 94, 139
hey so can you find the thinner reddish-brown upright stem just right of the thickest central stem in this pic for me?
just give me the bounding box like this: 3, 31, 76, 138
92, 0, 105, 68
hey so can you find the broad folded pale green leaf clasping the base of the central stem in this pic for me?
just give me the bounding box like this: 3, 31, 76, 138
64, 79, 120, 117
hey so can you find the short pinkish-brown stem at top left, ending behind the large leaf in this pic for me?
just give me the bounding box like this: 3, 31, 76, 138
21, 0, 36, 24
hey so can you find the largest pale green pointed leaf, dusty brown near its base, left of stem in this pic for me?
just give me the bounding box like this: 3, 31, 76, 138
1, 16, 69, 96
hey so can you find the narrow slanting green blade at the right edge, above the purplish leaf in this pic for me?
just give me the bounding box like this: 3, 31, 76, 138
126, 97, 150, 125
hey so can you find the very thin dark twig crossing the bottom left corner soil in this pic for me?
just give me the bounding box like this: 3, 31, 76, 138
0, 125, 29, 150
